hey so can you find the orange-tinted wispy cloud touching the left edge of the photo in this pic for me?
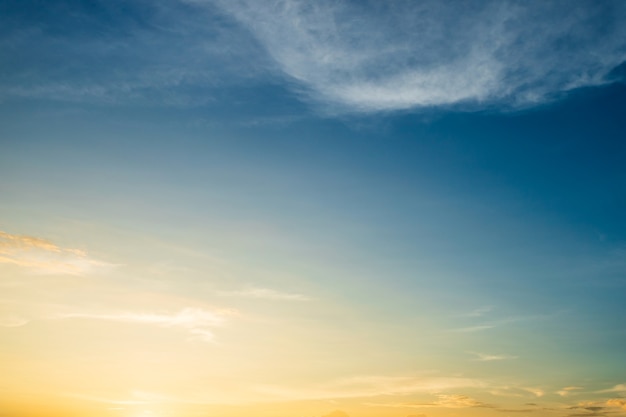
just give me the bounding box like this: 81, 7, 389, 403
0, 231, 115, 275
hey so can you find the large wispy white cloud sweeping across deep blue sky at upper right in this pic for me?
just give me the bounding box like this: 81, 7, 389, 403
211, 0, 626, 112
